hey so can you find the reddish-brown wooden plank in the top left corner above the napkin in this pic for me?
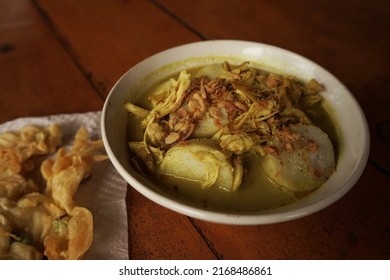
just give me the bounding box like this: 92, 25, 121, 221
0, 0, 103, 122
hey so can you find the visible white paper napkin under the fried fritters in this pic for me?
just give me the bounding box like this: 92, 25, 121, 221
0, 112, 128, 260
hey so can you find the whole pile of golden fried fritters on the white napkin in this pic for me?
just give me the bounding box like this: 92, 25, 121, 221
0, 125, 107, 259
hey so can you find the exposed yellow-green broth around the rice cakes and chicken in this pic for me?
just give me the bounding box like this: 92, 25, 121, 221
127, 61, 341, 213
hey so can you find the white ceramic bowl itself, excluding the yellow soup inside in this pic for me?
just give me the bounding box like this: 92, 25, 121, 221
101, 40, 369, 224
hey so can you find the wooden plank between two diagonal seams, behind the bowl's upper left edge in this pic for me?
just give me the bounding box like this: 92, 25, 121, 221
37, 0, 199, 96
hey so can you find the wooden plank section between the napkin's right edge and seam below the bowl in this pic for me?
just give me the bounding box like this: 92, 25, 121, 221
128, 189, 216, 260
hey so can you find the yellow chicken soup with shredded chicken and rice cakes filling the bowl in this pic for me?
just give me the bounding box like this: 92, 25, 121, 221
125, 62, 339, 212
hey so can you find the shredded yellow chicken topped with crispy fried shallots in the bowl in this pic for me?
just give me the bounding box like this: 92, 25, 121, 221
125, 62, 323, 190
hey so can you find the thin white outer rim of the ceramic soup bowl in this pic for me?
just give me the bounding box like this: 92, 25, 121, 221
101, 40, 370, 225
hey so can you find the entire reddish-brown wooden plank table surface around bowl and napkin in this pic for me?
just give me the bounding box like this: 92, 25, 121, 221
0, 0, 390, 259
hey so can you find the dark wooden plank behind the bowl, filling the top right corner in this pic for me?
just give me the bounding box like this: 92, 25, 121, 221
157, 0, 390, 174
